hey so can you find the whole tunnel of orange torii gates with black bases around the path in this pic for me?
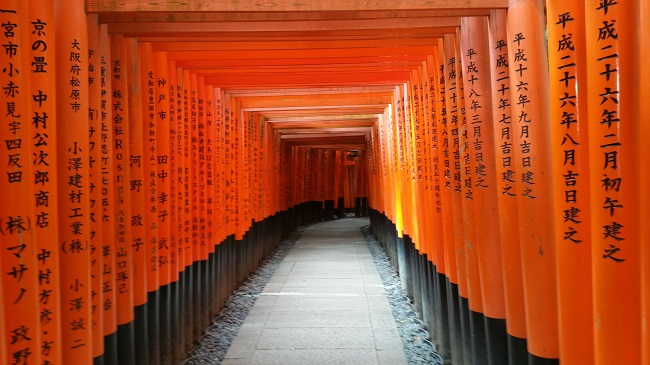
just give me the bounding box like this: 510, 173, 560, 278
0, 0, 650, 365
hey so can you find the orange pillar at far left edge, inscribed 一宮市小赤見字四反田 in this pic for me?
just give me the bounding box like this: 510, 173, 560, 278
0, 1, 41, 365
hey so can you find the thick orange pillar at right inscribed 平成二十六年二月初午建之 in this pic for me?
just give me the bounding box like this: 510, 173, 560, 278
576, 1, 636, 364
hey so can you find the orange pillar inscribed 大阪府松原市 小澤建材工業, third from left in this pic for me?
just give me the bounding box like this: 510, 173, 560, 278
56, 1, 92, 362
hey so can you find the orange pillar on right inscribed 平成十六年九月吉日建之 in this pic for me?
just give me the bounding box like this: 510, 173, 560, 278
507, 0, 559, 364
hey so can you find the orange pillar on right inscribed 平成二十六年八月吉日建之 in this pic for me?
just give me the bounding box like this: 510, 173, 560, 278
547, 1, 594, 364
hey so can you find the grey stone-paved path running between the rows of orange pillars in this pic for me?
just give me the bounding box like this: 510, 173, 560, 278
222, 218, 407, 365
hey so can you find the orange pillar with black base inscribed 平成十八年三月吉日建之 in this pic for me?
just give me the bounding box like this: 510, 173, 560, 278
461, 17, 507, 364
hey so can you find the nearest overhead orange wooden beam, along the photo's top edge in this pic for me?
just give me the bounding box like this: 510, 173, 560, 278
86, 0, 508, 13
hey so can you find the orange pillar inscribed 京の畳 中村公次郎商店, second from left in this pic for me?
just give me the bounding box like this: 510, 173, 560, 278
29, 3, 62, 363
